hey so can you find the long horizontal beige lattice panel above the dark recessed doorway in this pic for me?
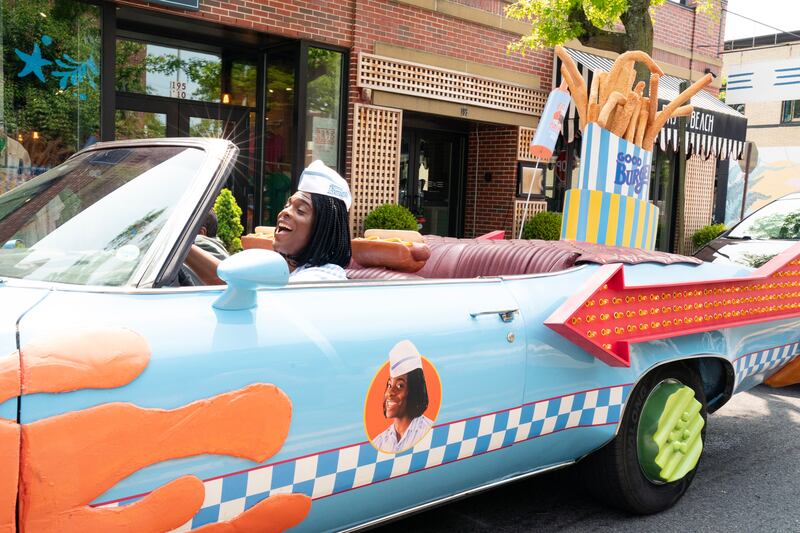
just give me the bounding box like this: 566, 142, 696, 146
356, 53, 547, 116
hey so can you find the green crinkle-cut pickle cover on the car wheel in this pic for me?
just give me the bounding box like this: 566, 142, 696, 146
637, 379, 705, 483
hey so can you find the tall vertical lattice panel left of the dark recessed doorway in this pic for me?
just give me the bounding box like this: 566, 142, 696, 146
350, 104, 403, 237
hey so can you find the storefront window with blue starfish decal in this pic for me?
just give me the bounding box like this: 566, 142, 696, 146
0, 0, 100, 193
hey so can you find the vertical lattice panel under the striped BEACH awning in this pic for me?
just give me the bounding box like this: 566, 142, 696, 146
678, 155, 717, 255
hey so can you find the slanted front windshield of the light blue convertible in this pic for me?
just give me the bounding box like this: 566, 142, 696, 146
0, 146, 206, 286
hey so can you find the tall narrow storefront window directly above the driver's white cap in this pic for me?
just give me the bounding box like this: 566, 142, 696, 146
305, 47, 343, 171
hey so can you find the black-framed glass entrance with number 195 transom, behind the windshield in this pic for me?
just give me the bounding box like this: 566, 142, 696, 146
115, 32, 260, 232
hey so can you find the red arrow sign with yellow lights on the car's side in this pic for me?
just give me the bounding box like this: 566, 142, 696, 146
544, 243, 800, 366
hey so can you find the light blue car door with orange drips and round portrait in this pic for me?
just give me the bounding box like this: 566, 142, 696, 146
19, 279, 536, 531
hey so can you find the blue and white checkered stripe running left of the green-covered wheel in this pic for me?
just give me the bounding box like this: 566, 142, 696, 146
97, 385, 631, 531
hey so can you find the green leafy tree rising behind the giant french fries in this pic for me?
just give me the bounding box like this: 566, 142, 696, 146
506, 0, 720, 68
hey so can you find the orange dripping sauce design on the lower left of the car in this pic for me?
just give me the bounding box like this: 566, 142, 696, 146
0, 329, 311, 532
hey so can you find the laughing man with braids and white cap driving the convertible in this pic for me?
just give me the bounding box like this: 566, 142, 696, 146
273, 161, 352, 283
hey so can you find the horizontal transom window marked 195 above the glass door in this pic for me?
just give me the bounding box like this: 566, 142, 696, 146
116, 39, 222, 102
